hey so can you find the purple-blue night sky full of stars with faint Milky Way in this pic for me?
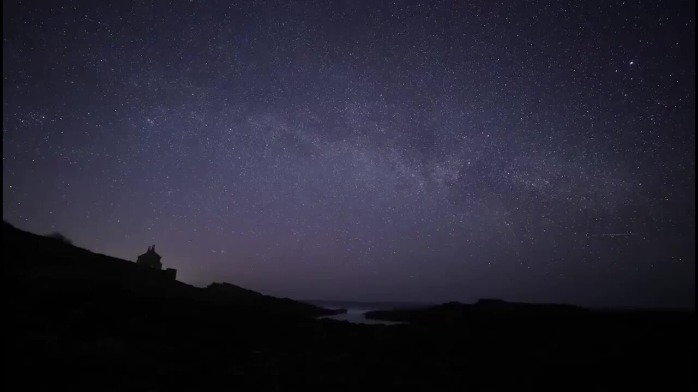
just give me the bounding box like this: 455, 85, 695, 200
2, 0, 695, 307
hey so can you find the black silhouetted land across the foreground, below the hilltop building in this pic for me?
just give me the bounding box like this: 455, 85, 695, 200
2, 224, 696, 391
